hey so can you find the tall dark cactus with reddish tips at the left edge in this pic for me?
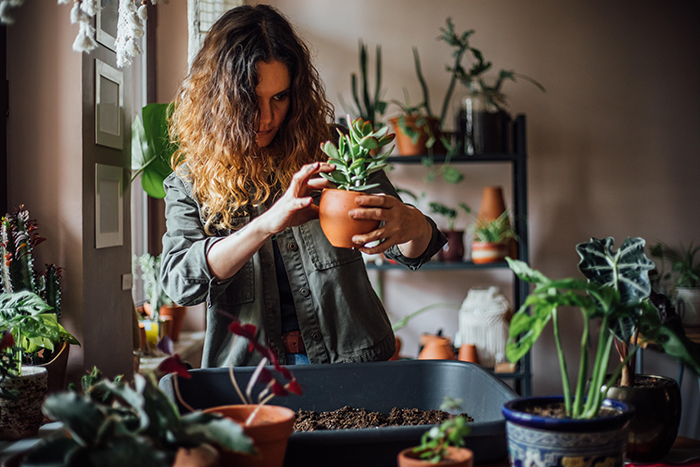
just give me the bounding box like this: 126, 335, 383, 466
0, 205, 63, 318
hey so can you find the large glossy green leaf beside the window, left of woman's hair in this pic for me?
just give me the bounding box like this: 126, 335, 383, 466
131, 104, 177, 198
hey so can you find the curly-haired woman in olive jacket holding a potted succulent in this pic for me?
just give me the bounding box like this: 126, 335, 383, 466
161, 5, 444, 367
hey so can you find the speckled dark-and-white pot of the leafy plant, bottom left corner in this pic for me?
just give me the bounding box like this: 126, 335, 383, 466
0, 365, 49, 439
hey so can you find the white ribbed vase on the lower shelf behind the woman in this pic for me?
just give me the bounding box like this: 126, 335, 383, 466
459, 286, 511, 367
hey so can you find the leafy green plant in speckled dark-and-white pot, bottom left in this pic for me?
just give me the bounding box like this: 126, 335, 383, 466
0, 291, 78, 439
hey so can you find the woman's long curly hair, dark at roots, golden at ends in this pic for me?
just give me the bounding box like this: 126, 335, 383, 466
170, 5, 333, 233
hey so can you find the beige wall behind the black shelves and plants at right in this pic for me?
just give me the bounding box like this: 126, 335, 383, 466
154, 0, 700, 437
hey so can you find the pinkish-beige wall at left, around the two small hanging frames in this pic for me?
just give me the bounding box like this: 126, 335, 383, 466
7, 0, 133, 380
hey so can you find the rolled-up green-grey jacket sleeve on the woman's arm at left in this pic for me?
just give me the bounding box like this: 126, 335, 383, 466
160, 173, 235, 306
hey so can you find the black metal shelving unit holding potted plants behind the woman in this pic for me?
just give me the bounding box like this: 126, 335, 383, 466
367, 115, 532, 397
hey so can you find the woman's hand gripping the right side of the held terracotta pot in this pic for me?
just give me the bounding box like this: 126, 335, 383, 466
350, 195, 432, 258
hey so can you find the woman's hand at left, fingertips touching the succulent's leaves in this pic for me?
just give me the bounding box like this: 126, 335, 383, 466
260, 162, 335, 235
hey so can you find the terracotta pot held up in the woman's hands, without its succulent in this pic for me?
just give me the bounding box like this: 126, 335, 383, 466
318, 189, 379, 248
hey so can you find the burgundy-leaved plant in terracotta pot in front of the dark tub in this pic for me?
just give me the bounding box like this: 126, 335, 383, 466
159, 317, 302, 467
